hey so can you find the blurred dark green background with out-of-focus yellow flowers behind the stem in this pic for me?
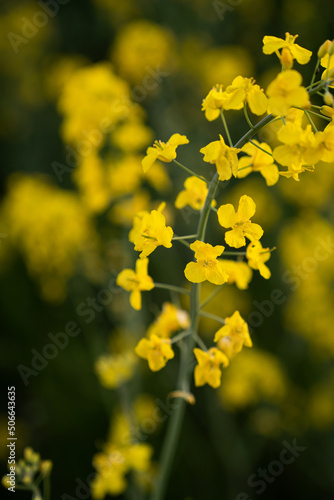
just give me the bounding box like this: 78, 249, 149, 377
0, 0, 334, 500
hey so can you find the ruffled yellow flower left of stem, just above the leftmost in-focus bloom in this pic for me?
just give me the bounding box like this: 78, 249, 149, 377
129, 203, 174, 259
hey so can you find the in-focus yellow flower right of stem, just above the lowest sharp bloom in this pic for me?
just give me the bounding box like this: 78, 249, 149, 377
214, 311, 253, 358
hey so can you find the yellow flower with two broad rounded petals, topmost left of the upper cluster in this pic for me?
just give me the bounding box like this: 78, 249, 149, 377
224, 76, 268, 115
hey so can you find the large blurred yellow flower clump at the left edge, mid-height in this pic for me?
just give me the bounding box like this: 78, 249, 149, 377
1, 174, 97, 302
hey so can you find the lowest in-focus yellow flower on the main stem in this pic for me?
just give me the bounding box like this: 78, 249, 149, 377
194, 347, 229, 389
